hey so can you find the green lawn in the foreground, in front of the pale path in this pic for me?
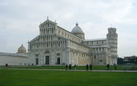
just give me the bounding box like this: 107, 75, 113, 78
0, 69, 137, 86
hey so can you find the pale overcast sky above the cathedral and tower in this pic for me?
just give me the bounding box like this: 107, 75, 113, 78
0, 0, 137, 57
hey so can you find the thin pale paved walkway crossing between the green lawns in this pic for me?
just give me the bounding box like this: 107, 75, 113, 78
0, 68, 137, 72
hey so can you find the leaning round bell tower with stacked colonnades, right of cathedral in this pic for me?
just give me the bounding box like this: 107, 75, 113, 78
107, 27, 118, 64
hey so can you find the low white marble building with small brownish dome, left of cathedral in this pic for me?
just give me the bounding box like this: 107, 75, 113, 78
0, 45, 29, 66
